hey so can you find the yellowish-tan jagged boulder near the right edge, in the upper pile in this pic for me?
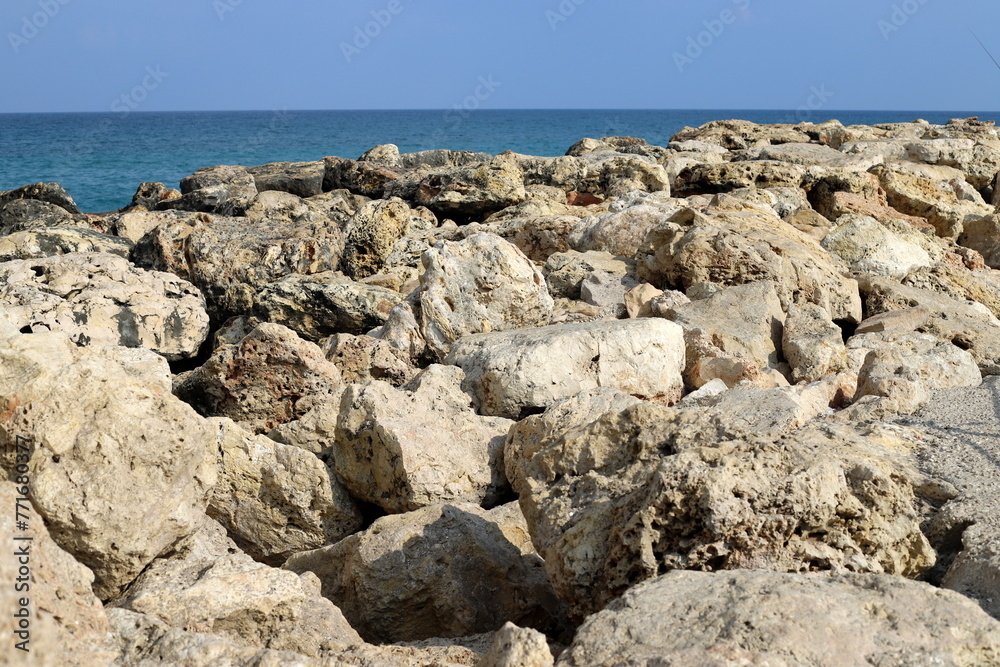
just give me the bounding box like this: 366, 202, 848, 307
872, 162, 994, 239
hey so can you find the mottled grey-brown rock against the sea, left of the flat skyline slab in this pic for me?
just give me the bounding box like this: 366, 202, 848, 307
156, 166, 257, 215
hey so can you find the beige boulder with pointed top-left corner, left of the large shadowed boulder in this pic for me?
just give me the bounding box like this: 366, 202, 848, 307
208, 419, 363, 567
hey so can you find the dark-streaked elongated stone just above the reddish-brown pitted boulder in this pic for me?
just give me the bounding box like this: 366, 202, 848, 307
255, 273, 403, 342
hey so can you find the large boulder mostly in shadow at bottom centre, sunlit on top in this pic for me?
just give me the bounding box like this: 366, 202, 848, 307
285, 504, 561, 643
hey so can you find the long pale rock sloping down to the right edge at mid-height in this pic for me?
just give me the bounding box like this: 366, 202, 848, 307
860, 276, 1000, 375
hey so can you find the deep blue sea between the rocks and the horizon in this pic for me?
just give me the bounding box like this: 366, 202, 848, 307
0, 110, 1000, 212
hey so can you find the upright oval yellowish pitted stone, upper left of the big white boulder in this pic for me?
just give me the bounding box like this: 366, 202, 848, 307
343, 199, 411, 279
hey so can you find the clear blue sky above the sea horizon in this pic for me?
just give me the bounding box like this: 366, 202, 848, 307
0, 0, 1000, 112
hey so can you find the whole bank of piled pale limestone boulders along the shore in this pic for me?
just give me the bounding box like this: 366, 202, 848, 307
0, 118, 1000, 667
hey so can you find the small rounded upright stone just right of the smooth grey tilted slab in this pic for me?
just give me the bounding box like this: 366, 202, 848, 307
781, 303, 847, 383
